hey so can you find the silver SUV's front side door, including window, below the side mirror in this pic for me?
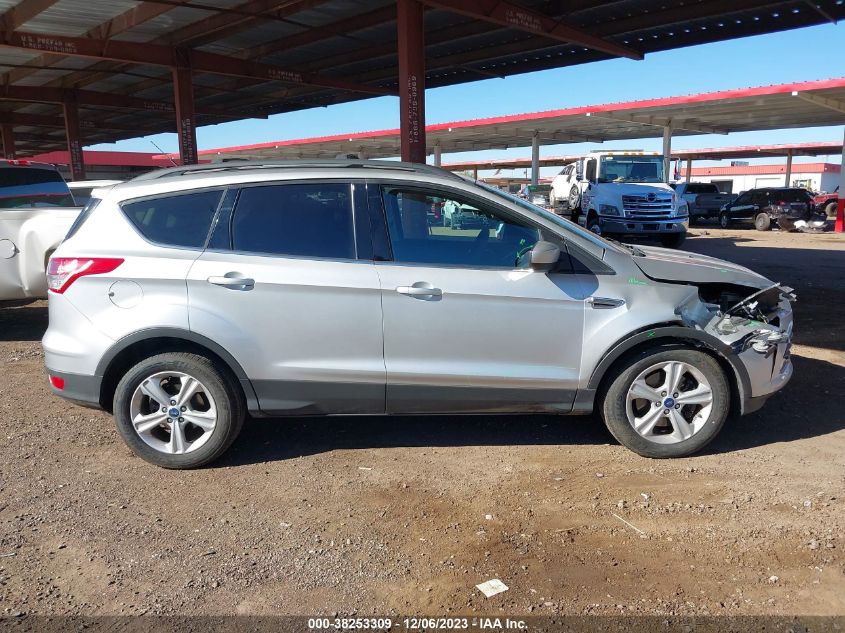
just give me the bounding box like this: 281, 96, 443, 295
368, 184, 586, 413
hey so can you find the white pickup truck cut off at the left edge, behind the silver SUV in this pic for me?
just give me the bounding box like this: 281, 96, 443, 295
0, 160, 80, 307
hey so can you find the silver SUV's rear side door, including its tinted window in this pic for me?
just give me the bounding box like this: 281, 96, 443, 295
188, 181, 385, 415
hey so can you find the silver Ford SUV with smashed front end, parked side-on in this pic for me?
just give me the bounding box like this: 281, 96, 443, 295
44, 161, 794, 468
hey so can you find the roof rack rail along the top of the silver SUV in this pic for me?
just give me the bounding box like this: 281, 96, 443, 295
132, 158, 459, 181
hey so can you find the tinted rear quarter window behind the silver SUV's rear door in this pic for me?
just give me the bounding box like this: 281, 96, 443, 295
121, 191, 223, 248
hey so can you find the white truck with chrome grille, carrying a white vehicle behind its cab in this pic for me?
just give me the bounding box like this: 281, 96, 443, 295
551, 151, 689, 247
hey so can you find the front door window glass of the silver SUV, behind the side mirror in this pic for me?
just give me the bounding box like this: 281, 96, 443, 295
382, 187, 540, 268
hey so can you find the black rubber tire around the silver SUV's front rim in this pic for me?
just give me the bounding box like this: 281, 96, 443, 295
599, 346, 730, 459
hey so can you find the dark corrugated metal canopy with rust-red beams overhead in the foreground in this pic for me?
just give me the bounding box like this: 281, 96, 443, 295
0, 0, 845, 155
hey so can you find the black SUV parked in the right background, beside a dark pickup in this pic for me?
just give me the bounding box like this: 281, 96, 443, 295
719, 187, 815, 231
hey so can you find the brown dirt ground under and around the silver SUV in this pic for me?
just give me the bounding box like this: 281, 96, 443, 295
0, 228, 845, 616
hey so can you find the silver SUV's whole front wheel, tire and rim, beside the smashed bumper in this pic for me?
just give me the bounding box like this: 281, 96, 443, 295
601, 347, 730, 458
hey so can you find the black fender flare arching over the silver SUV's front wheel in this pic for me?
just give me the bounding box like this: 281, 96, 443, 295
587, 325, 751, 410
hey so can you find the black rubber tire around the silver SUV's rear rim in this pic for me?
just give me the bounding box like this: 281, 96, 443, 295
113, 352, 246, 469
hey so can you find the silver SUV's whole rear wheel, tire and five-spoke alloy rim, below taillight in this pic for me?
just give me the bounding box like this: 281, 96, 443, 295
114, 352, 246, 469
